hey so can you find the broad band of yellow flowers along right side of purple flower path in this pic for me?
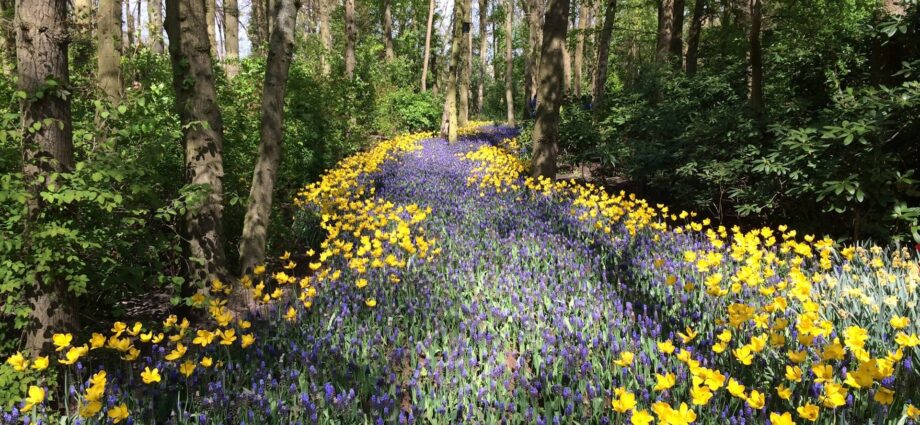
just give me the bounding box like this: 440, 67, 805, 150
465, 130, 920, 425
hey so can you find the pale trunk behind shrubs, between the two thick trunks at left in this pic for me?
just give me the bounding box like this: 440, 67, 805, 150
96, 0, 122, 105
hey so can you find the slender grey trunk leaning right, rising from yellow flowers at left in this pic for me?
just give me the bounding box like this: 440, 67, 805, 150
240, 0, 300, 274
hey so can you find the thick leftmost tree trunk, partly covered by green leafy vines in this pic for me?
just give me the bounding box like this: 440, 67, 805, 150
14, 0, 77, 355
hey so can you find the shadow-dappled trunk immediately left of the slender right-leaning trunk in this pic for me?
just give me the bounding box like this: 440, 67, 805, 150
166, 0, 227, 284
